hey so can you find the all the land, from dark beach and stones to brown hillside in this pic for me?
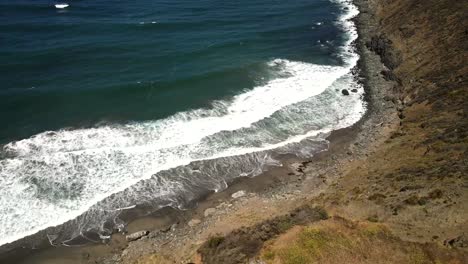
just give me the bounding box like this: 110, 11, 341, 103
4, 0, 468, 263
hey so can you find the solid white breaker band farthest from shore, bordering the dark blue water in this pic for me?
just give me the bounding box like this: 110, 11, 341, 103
6, 59, 349, 157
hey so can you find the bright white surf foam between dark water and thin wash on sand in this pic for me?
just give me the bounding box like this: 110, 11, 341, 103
0, 1, 364, 245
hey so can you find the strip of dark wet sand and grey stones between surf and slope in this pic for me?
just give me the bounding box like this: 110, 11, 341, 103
0, 0, 402, 263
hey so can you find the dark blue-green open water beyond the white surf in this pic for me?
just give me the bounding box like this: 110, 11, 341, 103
0, 0, 342, 144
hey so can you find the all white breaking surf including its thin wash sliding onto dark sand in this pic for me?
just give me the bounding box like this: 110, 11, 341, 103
0, 0, 365, 248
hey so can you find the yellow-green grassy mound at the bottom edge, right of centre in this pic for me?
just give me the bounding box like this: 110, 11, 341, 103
261, 218, 466, 264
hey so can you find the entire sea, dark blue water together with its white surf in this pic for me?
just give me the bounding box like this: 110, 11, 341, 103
0, 0, 365, 245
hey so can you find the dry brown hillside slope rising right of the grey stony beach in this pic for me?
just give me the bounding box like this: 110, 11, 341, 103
326, 0, 468, 243
